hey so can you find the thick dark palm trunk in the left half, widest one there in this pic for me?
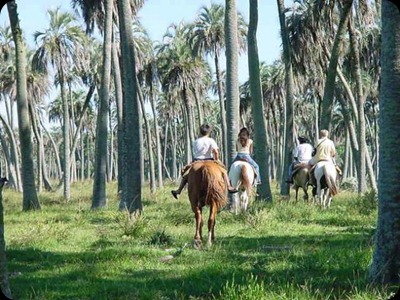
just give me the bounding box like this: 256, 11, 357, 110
118, 0, 143, 213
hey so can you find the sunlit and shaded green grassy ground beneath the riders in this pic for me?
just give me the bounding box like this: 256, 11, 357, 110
3, 183, 398, 300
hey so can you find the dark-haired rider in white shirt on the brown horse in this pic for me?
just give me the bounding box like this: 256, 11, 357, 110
171, 124, 238, 199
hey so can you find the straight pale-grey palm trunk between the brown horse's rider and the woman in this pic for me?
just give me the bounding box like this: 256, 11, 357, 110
225, 0, 240, 165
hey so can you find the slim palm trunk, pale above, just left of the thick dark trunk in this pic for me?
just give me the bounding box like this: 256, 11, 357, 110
92, 0, 114, 209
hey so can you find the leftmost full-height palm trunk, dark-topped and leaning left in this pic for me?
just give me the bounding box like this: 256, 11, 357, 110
7, 1, 40, 210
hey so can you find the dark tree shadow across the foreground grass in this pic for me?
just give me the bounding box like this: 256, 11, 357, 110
7, 227, 394, 300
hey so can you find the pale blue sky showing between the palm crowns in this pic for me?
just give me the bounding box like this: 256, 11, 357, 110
0, 0, 282, 116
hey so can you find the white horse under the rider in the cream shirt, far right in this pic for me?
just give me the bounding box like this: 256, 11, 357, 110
314, 161, 338, 208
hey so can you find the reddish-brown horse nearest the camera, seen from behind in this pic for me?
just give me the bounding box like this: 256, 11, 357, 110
188, 161, 228, 248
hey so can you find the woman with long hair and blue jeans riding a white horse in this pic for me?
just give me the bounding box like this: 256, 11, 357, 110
233, 127, 261, 184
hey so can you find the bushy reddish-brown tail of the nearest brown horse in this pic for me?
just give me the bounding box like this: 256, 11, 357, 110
201, 164, 228, 209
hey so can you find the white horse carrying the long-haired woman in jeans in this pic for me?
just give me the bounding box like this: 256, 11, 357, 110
229, 161, 255, 214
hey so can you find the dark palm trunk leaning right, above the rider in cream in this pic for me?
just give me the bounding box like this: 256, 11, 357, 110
321, 0, 353, 130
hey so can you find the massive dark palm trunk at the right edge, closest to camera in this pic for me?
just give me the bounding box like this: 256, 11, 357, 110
369, 1, 400, 284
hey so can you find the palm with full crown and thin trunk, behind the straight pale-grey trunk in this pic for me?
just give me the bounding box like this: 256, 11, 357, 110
188, 3, 247, 163
